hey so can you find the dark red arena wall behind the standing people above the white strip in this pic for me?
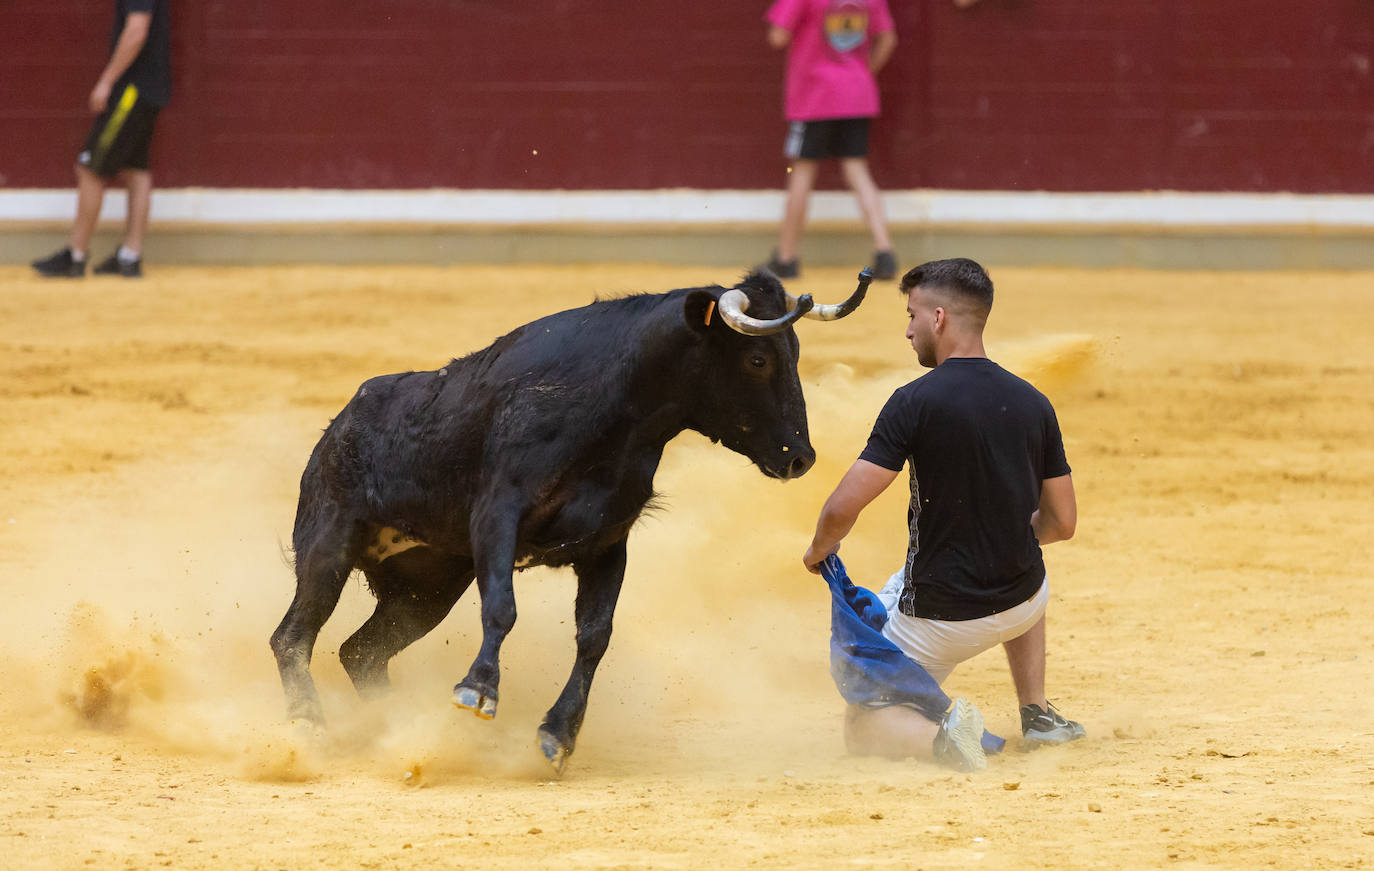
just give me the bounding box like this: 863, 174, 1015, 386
0, 0, 1374, 192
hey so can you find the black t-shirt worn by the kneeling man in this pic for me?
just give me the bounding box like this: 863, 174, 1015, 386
859, 357, 1069, 620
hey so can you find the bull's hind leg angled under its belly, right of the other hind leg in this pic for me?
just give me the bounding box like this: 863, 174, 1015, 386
339, 548, 473, 698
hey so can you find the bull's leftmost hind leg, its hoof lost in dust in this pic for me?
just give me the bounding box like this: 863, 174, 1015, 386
272, 516, 363, 724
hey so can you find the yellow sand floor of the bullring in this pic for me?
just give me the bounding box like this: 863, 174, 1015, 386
0, 265, 1374, 870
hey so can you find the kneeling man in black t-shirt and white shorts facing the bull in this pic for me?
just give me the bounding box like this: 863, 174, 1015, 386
802, 258, 1084, 756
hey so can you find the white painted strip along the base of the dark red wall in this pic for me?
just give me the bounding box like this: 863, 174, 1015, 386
8, 188, 1374, 229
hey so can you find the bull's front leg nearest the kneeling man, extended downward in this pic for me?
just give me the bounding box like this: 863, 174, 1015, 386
539, 541, 625, 773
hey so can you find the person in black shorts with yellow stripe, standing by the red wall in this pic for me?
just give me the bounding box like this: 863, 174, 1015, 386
33, 0, 172, 278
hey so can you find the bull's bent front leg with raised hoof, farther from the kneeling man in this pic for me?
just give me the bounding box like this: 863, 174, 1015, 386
453, 511, 519, 720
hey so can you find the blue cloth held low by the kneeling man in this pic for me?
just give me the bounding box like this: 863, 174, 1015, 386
820, 554, 1007, 753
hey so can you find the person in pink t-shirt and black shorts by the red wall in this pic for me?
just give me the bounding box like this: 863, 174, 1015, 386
764, 0, 897, 280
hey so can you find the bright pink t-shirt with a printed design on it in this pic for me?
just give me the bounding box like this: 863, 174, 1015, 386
764, 0, 893, 121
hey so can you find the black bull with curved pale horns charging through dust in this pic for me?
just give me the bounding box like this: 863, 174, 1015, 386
272, 269, 871, 771
